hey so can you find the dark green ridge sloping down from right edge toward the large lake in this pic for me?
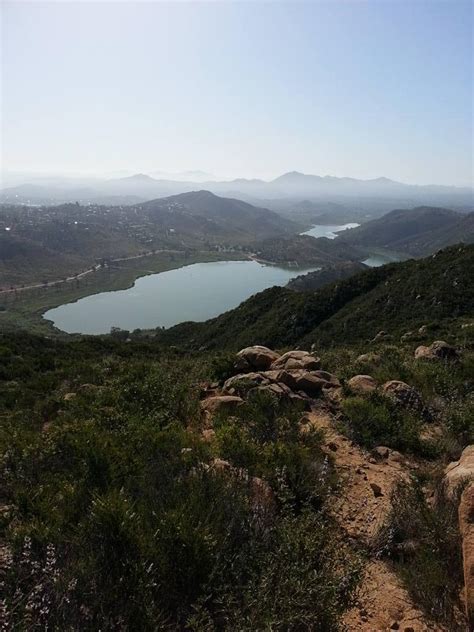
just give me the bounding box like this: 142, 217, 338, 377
157, 245, 474, 349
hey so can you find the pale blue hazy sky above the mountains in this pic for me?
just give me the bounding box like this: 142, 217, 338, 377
0, 0, 473, 185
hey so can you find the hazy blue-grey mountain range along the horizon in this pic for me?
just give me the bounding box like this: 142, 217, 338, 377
0, 171, 474, 215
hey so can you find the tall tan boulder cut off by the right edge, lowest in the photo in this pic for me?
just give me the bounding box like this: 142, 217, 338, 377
459, 483, 474, 630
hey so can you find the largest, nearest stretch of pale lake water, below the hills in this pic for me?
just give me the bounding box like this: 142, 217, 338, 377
44, 261, 318, 334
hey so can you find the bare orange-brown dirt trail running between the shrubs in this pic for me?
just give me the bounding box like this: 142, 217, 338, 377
307, 411, 447, 632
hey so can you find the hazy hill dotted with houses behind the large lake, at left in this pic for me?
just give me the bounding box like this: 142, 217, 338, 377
0, 190, 300, 287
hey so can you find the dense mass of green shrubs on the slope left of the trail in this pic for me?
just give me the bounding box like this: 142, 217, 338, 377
0, 337, 360, 631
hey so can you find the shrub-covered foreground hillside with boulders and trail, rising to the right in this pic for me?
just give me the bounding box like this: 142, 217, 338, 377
0, 247, 474, 632
